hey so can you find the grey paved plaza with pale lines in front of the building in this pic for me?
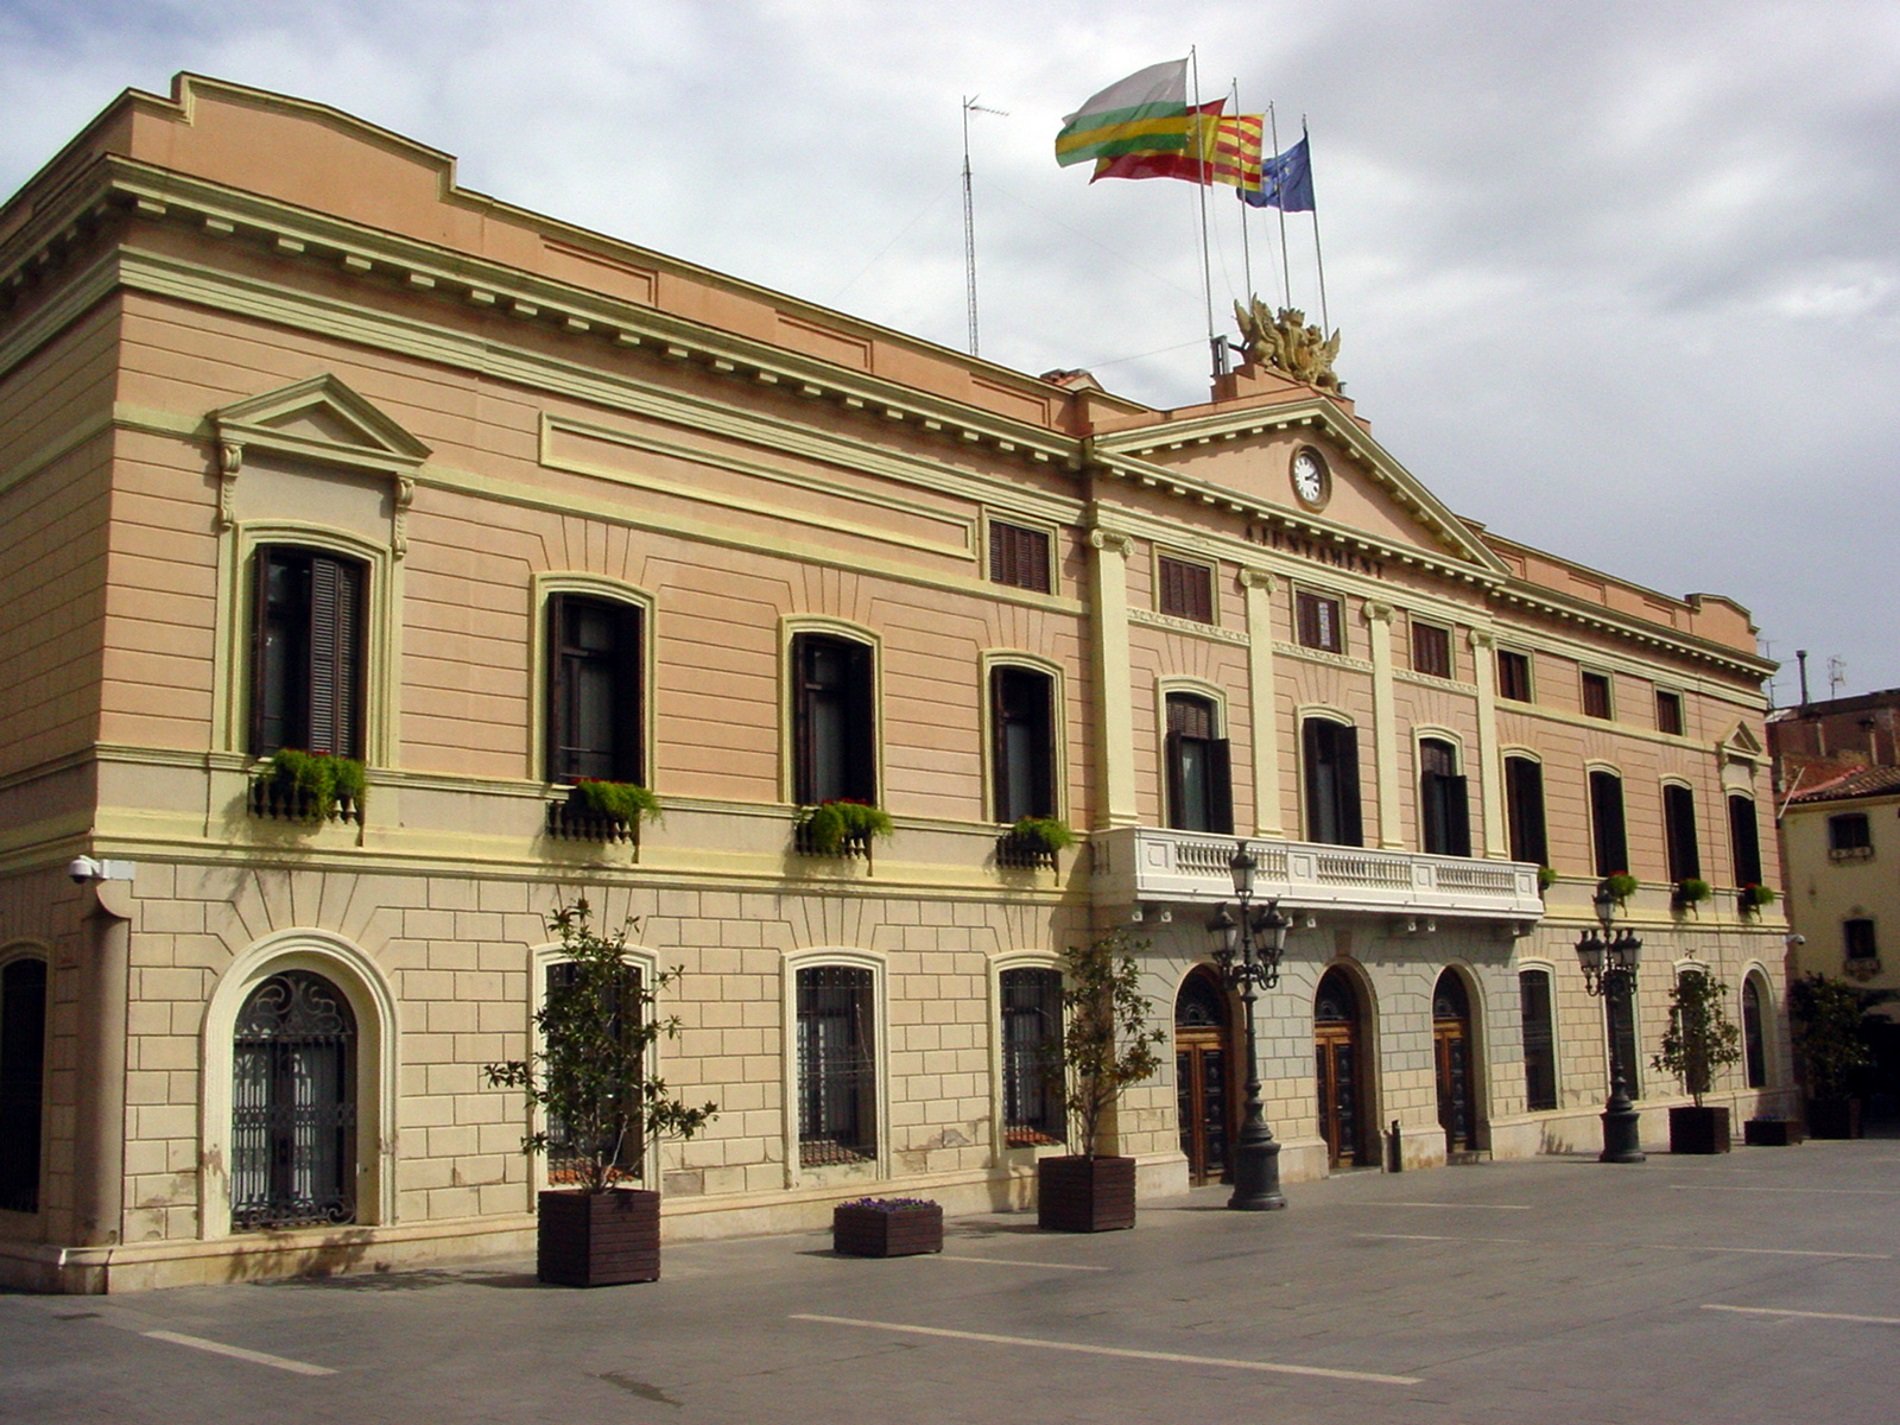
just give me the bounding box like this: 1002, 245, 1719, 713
0, 1138, 1900, 1425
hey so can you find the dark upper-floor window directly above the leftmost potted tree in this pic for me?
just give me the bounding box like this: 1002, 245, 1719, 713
547, 595, 646, 783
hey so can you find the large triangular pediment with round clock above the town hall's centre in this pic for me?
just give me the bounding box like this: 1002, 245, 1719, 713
1094, 391, 1511, 578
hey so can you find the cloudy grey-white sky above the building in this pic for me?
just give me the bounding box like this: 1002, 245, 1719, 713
0, 0, 1900, 705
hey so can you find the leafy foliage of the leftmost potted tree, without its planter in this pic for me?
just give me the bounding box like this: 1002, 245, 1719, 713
483, 897, 718, 1193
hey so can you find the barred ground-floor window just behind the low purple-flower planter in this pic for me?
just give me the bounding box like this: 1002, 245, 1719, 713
798, 965, 878, 1169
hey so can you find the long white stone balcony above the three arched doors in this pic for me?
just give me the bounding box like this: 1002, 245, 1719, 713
1089, 827, 1543, 922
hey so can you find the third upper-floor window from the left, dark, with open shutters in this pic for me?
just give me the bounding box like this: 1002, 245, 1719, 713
792, 633, 878, 806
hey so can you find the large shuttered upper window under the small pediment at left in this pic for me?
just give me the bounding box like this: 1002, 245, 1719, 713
251, 545, 365, 758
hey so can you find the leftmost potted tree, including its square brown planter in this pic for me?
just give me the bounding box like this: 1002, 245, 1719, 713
483, 897, 718, 1286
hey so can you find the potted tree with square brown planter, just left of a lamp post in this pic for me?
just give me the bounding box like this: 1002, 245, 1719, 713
1036, 931, 1167, 1231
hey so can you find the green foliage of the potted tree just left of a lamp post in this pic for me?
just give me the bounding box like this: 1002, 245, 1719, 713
1045, 931, 1167, 1157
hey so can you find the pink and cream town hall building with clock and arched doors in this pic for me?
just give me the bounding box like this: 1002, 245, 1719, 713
0, 76, 1790, 1290
